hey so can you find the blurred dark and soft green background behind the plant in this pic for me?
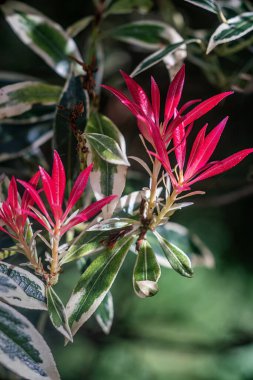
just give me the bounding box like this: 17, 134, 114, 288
0, 0, 253, 380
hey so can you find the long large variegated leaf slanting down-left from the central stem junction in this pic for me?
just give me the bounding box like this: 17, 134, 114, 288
67, 236, 134, 335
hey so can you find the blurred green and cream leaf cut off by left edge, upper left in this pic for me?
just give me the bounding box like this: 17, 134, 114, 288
0, 82, 61, 119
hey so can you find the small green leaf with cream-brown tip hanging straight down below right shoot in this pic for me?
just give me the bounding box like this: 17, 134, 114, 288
133, 240, 161, 298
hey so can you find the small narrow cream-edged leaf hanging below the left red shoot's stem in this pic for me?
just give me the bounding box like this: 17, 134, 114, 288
47, 287, 73, 342
